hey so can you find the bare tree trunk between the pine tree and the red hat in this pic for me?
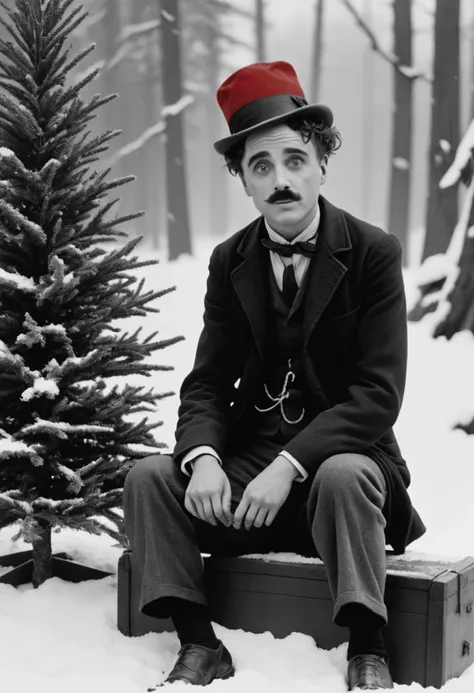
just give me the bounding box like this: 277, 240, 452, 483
160, 0, 191, 260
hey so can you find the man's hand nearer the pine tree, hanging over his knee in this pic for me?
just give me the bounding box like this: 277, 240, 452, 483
184, 455, 232, 527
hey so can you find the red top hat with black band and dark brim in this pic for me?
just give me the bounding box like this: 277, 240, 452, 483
214, 60, 334, 154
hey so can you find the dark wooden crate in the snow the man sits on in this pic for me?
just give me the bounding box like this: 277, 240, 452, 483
118, 552, 474, 688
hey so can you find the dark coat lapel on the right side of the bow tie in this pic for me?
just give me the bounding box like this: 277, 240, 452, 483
303, 195, 352, 350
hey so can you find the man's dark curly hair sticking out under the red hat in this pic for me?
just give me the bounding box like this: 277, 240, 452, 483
224, 116, 342, 176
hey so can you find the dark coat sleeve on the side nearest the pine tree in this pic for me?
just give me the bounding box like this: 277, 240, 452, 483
173, 246, 238, 462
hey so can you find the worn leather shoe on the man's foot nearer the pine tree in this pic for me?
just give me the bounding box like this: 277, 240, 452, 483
156, 640, 235, 686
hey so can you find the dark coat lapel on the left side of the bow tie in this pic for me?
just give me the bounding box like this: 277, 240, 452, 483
231, 217, 268, 361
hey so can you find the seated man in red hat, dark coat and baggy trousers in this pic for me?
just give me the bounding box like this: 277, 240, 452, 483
124, 62, 424, 690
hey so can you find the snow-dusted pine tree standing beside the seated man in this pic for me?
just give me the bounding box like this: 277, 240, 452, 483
0, 0, 181, 586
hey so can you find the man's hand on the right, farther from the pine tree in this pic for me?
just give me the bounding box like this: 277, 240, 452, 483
233, 455, 298, 529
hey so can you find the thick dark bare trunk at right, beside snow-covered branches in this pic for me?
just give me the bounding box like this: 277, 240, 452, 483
423, 0, 460, 260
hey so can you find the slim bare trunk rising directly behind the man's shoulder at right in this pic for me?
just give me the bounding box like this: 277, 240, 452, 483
388, 0, 413, 265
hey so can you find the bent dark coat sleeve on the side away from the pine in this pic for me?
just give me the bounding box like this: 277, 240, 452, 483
285, 235, 407, 474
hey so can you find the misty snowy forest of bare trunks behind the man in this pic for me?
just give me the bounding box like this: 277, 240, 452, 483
0, 0, 474, 265
